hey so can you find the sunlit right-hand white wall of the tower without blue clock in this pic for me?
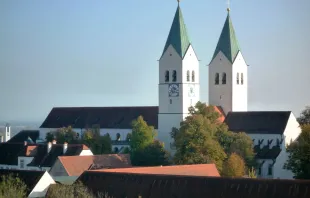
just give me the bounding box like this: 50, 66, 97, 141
232, 51, 248, 111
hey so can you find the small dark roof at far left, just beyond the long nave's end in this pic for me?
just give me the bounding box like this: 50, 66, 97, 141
7, 130, 40, 143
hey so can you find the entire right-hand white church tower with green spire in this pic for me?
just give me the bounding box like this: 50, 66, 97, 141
209, 8, 248, 115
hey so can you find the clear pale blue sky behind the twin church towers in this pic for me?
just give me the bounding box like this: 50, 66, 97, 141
0, 0, 310, 123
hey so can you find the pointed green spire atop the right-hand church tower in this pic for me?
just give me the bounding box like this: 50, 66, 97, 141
211, 9, 240, 63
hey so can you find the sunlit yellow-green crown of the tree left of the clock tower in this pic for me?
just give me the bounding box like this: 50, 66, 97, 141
130, 116, 156, 152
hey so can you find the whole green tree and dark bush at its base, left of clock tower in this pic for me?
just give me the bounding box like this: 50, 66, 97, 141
129, 116, 169, 166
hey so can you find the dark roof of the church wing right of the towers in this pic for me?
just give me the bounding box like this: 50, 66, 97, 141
224, 111, 291, 134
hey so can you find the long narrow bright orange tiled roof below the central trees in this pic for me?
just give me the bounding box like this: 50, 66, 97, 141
94, 164, 220, 177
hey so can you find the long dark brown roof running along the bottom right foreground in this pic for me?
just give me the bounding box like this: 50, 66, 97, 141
77, 171, 310, 198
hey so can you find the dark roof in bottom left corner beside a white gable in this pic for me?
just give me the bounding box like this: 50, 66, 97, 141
0, 169, 45, 195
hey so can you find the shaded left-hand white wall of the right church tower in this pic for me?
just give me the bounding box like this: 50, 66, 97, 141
209, 51, 232, 115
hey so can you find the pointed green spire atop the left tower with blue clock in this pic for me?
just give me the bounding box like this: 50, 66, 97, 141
162, 5, 190, 58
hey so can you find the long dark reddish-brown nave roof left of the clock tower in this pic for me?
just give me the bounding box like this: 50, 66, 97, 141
40, 106, 158, 129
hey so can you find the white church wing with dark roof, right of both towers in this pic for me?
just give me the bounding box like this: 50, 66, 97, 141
224, 111, 301, 179
